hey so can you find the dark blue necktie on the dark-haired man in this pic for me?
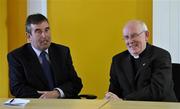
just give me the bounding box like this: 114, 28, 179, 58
40, 51, 54, 90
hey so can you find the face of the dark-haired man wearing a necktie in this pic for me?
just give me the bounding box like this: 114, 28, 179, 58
27, 21, 51, 51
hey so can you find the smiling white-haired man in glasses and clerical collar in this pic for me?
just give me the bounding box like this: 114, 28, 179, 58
105, 20, 176, 101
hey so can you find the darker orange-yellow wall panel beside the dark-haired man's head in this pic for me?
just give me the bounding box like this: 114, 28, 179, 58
7, 0, 27, 51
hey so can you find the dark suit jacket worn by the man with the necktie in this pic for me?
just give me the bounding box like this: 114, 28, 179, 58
7, 43, 82, 98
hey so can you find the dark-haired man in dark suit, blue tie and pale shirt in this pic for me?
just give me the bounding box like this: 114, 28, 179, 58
8, 14, 82, 98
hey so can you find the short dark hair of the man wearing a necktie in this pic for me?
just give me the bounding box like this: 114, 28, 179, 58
26, 13, 48, 34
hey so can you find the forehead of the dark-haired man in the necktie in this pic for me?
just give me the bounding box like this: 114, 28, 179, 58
31, 21, 49, 29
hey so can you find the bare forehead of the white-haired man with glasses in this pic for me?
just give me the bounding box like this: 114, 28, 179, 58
123, 22, 142, 35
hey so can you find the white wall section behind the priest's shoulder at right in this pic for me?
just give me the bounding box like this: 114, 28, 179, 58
153, 0, 180, 63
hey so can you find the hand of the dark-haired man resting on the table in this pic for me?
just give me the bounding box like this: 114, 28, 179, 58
37, 90, 60, 99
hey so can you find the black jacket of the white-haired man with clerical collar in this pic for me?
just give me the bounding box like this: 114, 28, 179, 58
109, 44, 176, 101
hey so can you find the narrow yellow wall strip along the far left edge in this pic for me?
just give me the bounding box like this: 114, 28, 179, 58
0, 0, 8, 98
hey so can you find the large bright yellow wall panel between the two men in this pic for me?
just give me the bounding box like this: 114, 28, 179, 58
48, 0, 152, 98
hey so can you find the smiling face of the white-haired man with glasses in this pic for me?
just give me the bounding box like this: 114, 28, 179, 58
123, 23, 149, 56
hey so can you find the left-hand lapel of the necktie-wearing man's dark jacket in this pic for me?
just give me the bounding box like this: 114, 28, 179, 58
27, 44, 48, 87
